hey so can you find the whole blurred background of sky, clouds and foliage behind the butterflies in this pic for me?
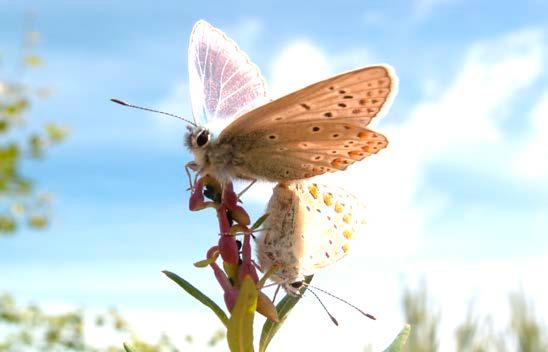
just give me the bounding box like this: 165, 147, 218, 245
0, 0, 548, 351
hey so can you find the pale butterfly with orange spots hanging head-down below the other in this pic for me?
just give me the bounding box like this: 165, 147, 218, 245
256, 180, 365, 296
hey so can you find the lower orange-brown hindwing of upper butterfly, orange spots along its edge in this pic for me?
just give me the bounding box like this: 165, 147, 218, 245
220, 120, 388, 181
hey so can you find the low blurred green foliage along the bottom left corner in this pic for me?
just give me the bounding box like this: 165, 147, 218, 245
0, 295, 225, 352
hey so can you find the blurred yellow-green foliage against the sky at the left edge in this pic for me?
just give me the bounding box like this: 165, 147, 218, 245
0, 17, 68, 236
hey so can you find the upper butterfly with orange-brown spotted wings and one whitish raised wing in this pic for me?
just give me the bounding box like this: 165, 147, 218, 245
185, 20, 397, 182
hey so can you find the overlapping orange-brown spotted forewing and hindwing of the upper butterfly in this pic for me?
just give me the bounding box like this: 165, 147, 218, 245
219, 66, 397, 181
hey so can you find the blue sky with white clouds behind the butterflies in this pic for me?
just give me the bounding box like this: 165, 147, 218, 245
0, 0, 548, 348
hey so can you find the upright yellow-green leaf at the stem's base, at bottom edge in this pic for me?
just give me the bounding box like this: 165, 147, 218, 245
226, 276, 258, 352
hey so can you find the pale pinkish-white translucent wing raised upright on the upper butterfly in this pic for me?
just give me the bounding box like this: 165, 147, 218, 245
188, 20, 266, 125
